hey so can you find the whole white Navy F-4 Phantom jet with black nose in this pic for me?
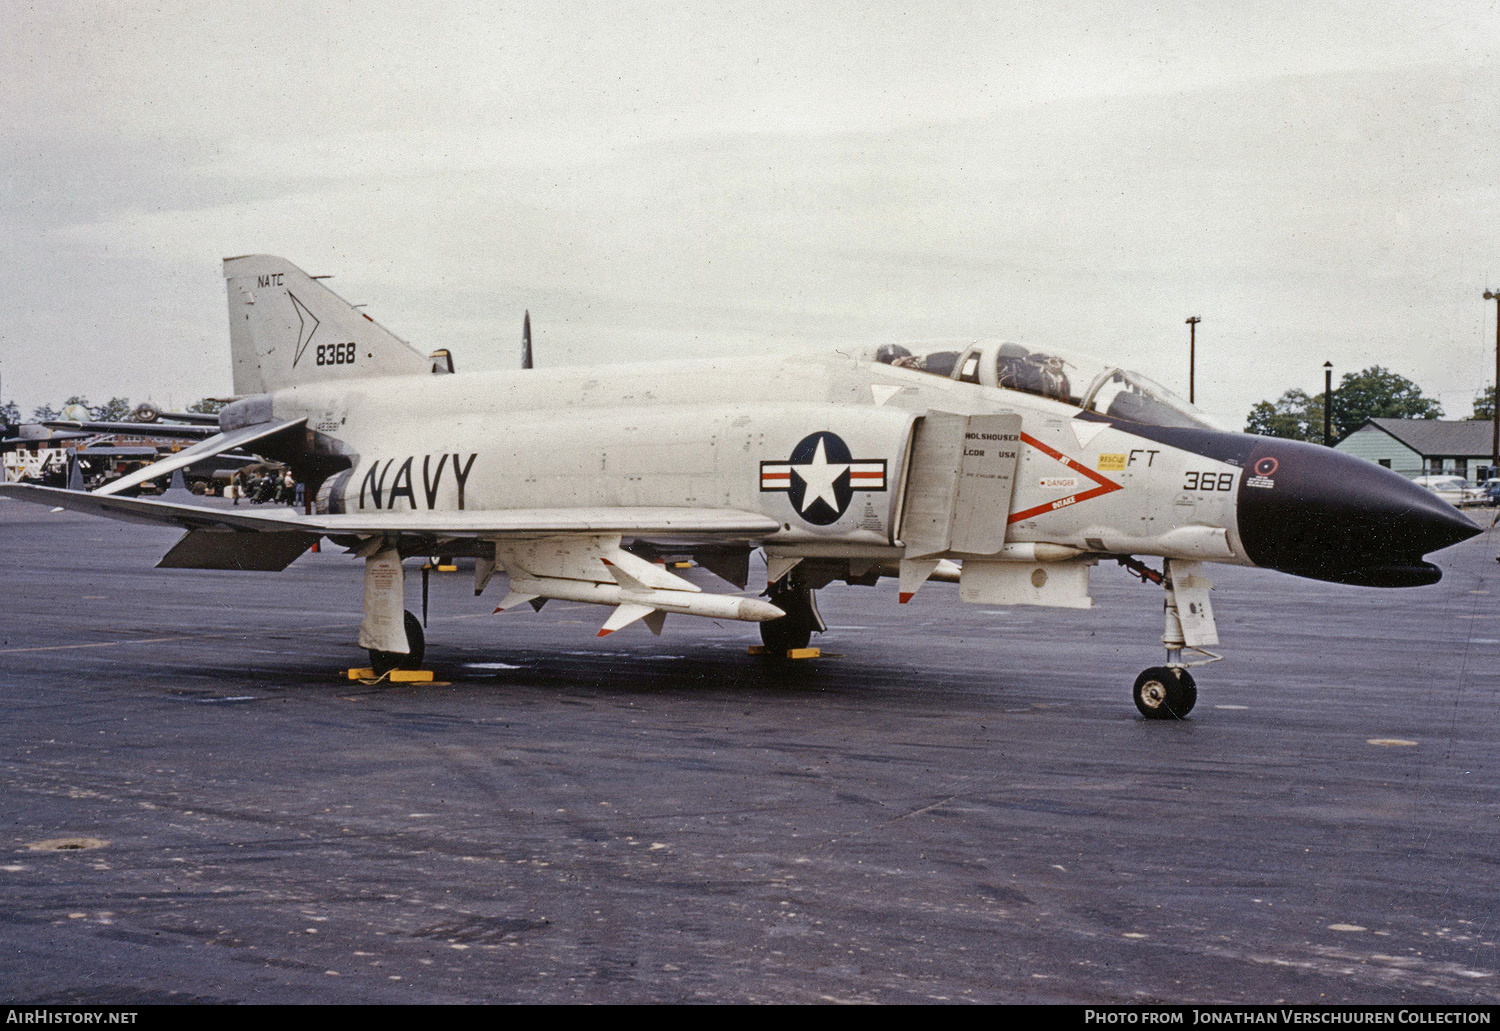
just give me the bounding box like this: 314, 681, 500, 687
0, 255, 1479, 717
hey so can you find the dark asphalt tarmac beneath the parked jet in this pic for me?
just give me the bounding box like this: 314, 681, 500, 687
0, 501, 1500, 1004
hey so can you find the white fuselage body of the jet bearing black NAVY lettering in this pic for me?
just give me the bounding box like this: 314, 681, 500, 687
272, 356, 1248, 564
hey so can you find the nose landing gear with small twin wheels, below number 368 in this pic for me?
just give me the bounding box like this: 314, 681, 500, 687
1122, 558, 1221, 719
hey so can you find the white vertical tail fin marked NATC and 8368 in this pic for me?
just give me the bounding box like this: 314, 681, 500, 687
224, 254, 432, 395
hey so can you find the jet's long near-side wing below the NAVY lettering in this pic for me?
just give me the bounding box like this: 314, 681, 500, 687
0, 486, 782, 540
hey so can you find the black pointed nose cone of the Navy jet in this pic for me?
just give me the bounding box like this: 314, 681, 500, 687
1239, 437, 1479, 587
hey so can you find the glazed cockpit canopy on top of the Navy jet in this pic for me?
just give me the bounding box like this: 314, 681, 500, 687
875, 341, 1221, 429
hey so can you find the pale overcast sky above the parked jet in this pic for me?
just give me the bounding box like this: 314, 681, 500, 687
0, 0, 1500, 426
